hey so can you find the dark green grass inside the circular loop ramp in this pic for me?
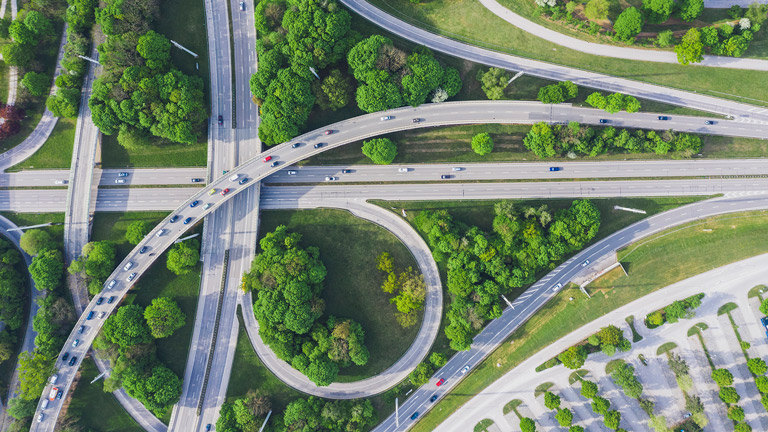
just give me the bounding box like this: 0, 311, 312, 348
259, 209, 420, 382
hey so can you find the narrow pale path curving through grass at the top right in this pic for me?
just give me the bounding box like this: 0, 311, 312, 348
480, 0, 768, 71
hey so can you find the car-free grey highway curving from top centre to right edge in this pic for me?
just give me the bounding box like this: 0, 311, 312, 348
341, 0, 768, 122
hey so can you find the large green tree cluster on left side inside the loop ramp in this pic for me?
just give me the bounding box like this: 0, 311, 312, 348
243, 225, 369, 385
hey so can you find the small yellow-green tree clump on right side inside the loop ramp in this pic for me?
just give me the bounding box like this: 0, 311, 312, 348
377, 252, 427, 327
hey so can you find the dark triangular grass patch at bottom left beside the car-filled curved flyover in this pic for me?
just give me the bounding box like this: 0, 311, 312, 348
67, 358, 144, 432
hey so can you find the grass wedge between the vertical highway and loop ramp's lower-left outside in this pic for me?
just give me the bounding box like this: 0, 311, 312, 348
227, 307, 306, 406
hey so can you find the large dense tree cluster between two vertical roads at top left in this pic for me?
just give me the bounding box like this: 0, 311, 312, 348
88, 0, 208, 144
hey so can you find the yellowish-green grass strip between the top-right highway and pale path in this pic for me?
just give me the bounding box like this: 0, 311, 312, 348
360, 0, 768, 105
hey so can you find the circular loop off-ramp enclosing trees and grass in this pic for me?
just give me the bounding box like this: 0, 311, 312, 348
240, 200, 443, 399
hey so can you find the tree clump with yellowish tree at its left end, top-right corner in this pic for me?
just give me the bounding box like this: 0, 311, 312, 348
675, 3, 768, 65
